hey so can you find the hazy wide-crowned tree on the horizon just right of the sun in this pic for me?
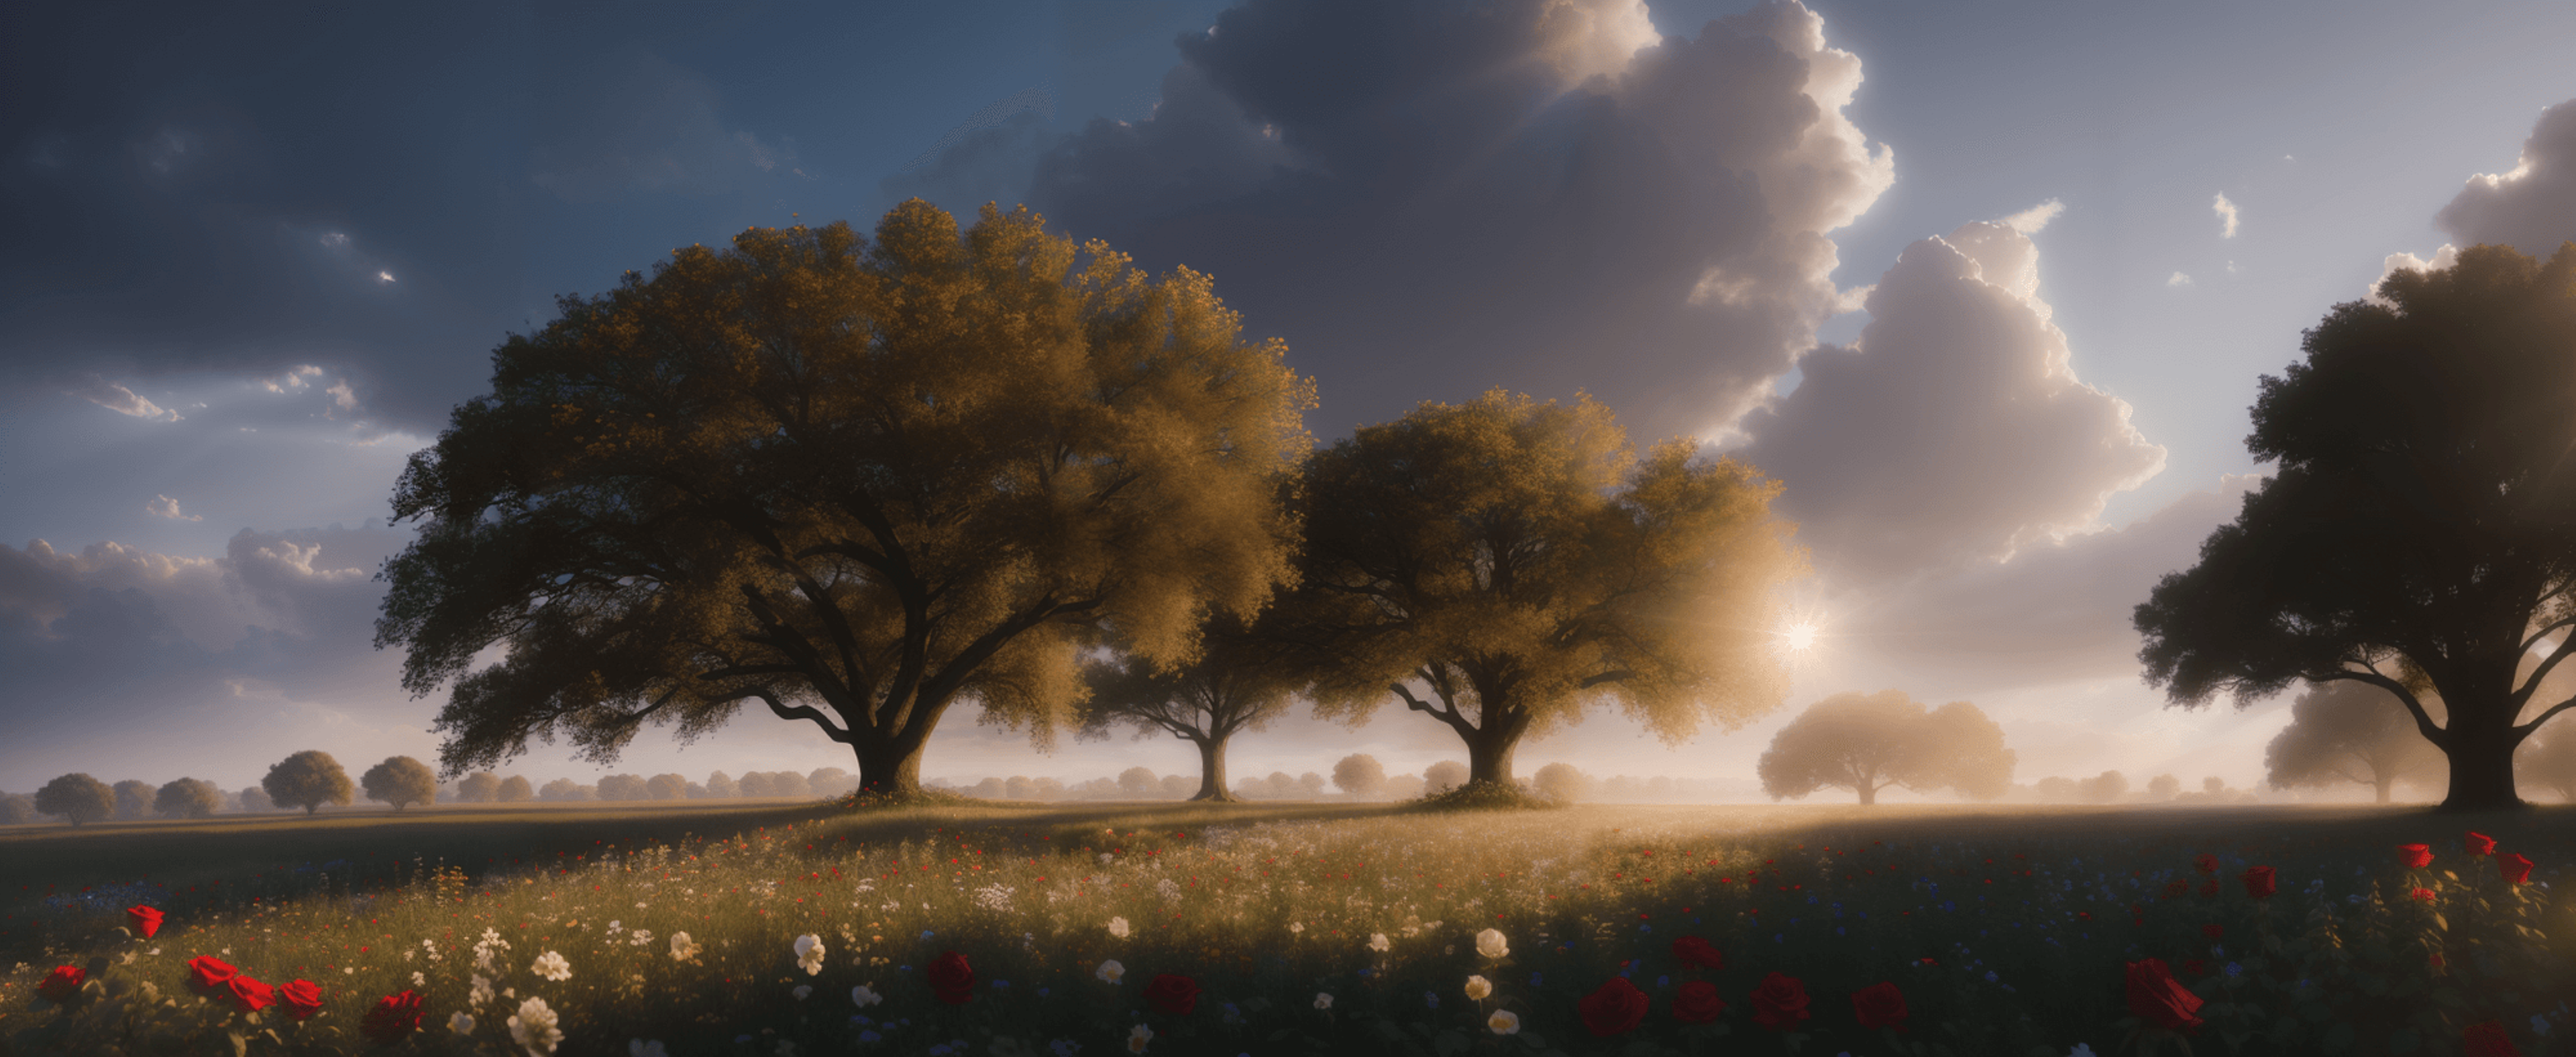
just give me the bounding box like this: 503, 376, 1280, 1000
1757, 691, 2017, 804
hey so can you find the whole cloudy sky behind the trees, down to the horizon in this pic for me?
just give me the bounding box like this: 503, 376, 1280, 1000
0, 0, 2576, 799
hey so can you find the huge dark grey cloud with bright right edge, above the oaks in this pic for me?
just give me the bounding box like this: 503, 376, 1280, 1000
889, 0, 1893, 436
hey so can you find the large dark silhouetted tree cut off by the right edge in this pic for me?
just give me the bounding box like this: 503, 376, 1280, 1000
2135, 245, 2576, 810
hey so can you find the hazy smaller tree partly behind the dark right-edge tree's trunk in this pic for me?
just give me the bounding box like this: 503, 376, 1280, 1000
2262, 678, 2442, 804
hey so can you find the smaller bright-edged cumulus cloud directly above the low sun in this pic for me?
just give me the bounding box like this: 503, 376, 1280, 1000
1741, 213, 2164, 586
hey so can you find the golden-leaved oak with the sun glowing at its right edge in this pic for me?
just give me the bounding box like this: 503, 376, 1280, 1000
1275, 392, 1803, 786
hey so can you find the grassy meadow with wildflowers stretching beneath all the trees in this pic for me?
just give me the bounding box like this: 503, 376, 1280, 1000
0, 801, 2576, 1057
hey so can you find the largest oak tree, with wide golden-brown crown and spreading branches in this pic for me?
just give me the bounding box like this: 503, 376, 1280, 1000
376, 201, 1311, 797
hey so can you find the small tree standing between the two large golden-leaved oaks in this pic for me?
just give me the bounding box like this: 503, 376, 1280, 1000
1077, 616, 1298, 801
